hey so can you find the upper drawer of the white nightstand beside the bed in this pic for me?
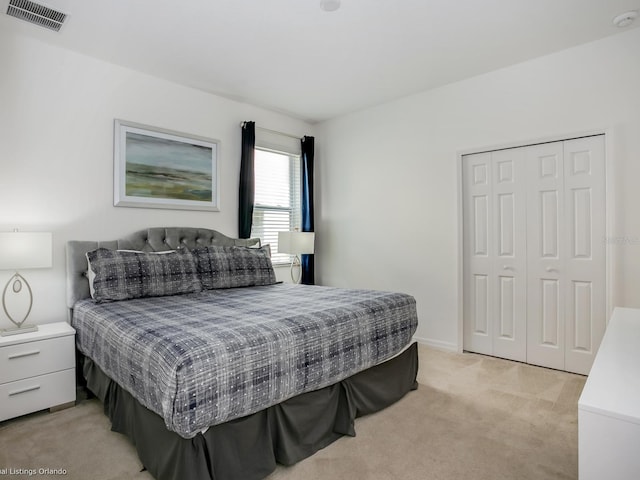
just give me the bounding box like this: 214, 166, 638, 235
0, 335, 75, 384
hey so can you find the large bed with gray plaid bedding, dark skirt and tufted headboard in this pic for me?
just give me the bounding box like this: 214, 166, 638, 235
67, 228, 418, 480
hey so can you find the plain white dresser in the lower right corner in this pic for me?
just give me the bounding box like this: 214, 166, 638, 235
578, 308, 640, 480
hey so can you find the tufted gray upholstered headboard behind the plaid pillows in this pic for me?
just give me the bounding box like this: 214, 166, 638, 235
67, 227, 260, 308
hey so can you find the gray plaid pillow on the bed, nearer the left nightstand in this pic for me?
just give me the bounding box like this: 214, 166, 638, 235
87, 248, 202, 302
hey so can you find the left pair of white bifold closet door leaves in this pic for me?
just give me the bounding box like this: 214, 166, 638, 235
463, 148, 527, 361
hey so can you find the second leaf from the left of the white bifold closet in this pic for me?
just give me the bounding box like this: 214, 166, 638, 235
490, 148, 527, 362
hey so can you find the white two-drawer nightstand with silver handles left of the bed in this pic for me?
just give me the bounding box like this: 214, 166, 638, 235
0, 322, 76, 421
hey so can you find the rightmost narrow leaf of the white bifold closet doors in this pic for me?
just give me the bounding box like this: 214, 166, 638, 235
564, 136, 606, 374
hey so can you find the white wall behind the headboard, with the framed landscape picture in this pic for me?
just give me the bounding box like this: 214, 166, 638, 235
0, 29, 313, 328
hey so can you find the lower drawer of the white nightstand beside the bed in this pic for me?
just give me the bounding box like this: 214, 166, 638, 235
0, 369, 76, 421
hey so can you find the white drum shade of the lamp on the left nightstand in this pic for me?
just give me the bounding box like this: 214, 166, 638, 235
0, 232, 53, 270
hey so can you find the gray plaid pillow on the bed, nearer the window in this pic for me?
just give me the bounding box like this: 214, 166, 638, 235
192, 245, 276, 289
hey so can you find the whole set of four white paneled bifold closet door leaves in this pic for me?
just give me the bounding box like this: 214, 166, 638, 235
462, 135, 606, 374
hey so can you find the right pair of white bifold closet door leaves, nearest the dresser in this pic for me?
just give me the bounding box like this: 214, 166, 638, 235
527, 135, 606, 374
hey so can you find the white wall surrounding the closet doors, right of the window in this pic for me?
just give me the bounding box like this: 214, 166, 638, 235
316, 29, 640, 348
